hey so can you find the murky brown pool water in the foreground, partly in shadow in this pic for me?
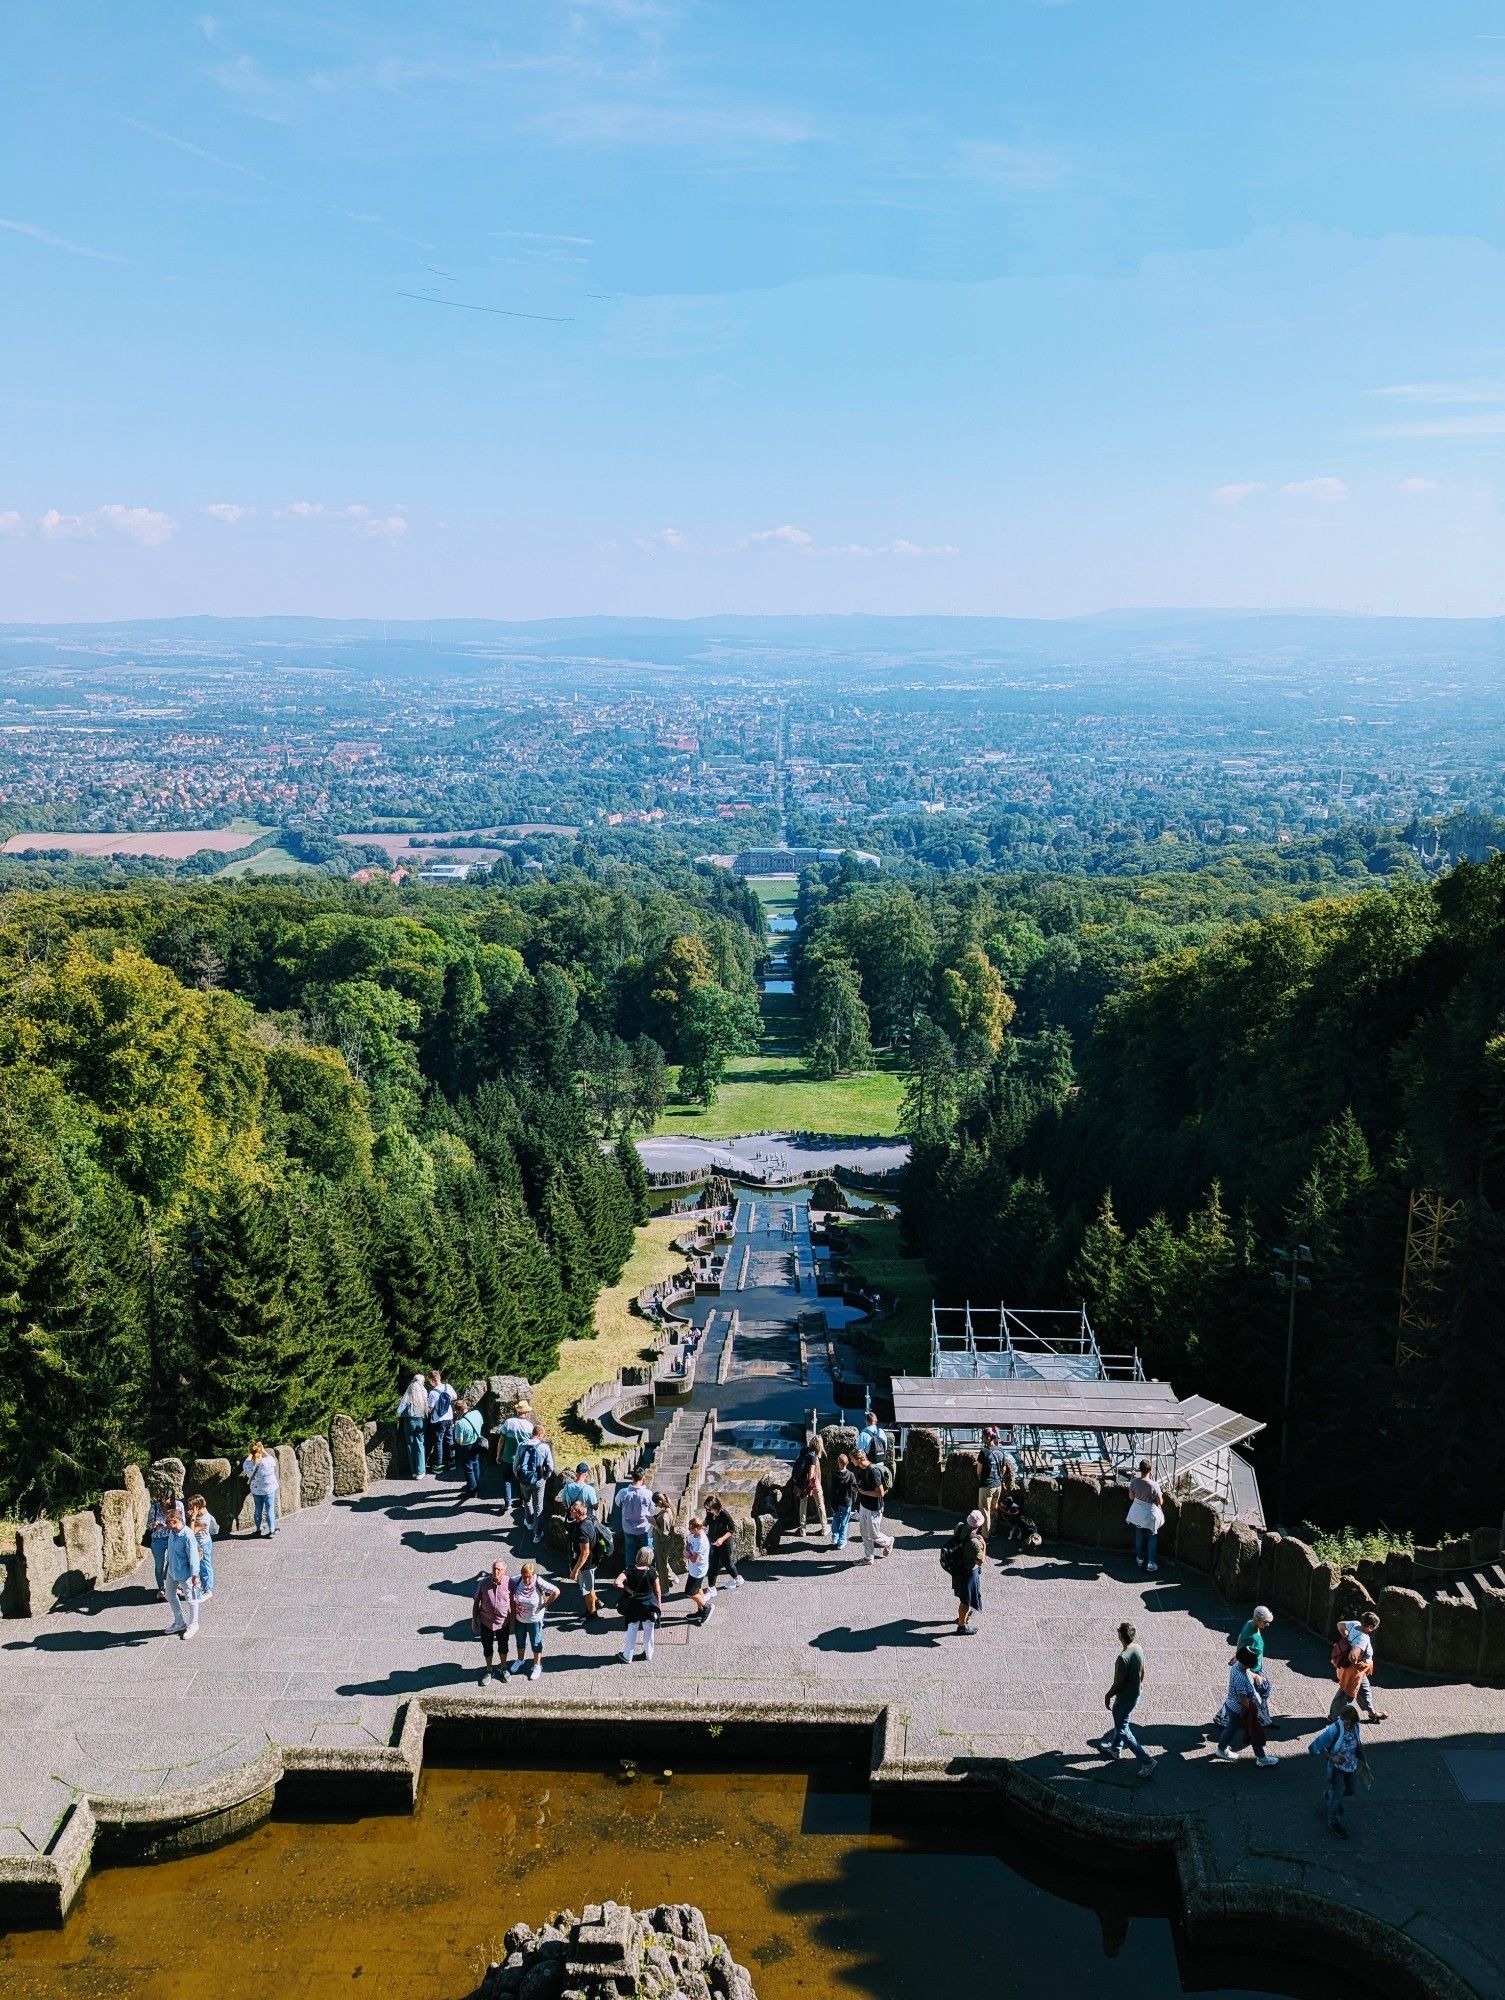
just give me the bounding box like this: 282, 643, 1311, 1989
0, 1768, 1296, 2000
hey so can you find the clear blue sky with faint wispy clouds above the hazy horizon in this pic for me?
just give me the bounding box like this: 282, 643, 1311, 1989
0, 0, 1505, 618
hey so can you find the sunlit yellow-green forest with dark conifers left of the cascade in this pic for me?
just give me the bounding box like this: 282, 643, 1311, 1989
0, 872, 761, 1510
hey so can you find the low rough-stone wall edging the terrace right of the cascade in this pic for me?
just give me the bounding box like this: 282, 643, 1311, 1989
897, 1428, 1505, 1680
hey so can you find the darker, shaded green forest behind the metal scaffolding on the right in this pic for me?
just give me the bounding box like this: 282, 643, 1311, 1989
799, 858, 1505, 1528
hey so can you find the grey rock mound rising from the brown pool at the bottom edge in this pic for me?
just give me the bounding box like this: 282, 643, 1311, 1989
480, 1902, 757, 2000
